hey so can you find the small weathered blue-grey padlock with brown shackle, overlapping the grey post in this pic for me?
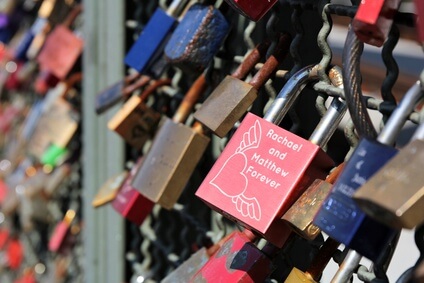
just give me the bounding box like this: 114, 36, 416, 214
95, 74, 150, 114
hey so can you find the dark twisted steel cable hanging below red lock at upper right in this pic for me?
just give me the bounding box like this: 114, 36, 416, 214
342, 28, 377, 139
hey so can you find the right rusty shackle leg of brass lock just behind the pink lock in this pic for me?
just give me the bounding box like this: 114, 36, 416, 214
249, 33, 291, 90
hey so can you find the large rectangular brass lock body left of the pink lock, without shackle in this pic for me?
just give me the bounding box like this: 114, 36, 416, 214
132, 118, 209, 209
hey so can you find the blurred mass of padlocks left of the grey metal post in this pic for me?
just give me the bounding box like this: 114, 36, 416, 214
0, 0, 83, 282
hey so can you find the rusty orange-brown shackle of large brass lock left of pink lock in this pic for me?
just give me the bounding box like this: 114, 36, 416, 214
172, 74, 206, 123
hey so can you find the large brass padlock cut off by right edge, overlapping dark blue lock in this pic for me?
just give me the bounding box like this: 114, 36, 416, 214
353, 81, 424, 229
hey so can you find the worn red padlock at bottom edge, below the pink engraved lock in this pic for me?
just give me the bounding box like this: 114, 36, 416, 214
189, 230, 273, 283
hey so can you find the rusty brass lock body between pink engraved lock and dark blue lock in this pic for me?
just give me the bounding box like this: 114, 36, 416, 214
282, 180, 331, 240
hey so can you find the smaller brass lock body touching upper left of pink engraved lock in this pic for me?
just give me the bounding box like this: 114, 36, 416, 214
194, 76, 258, 138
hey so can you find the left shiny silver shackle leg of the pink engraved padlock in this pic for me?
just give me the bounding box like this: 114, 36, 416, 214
264, 65, 318, 125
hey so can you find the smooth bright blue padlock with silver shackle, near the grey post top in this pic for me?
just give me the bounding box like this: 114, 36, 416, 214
125, 0, 187, 73
